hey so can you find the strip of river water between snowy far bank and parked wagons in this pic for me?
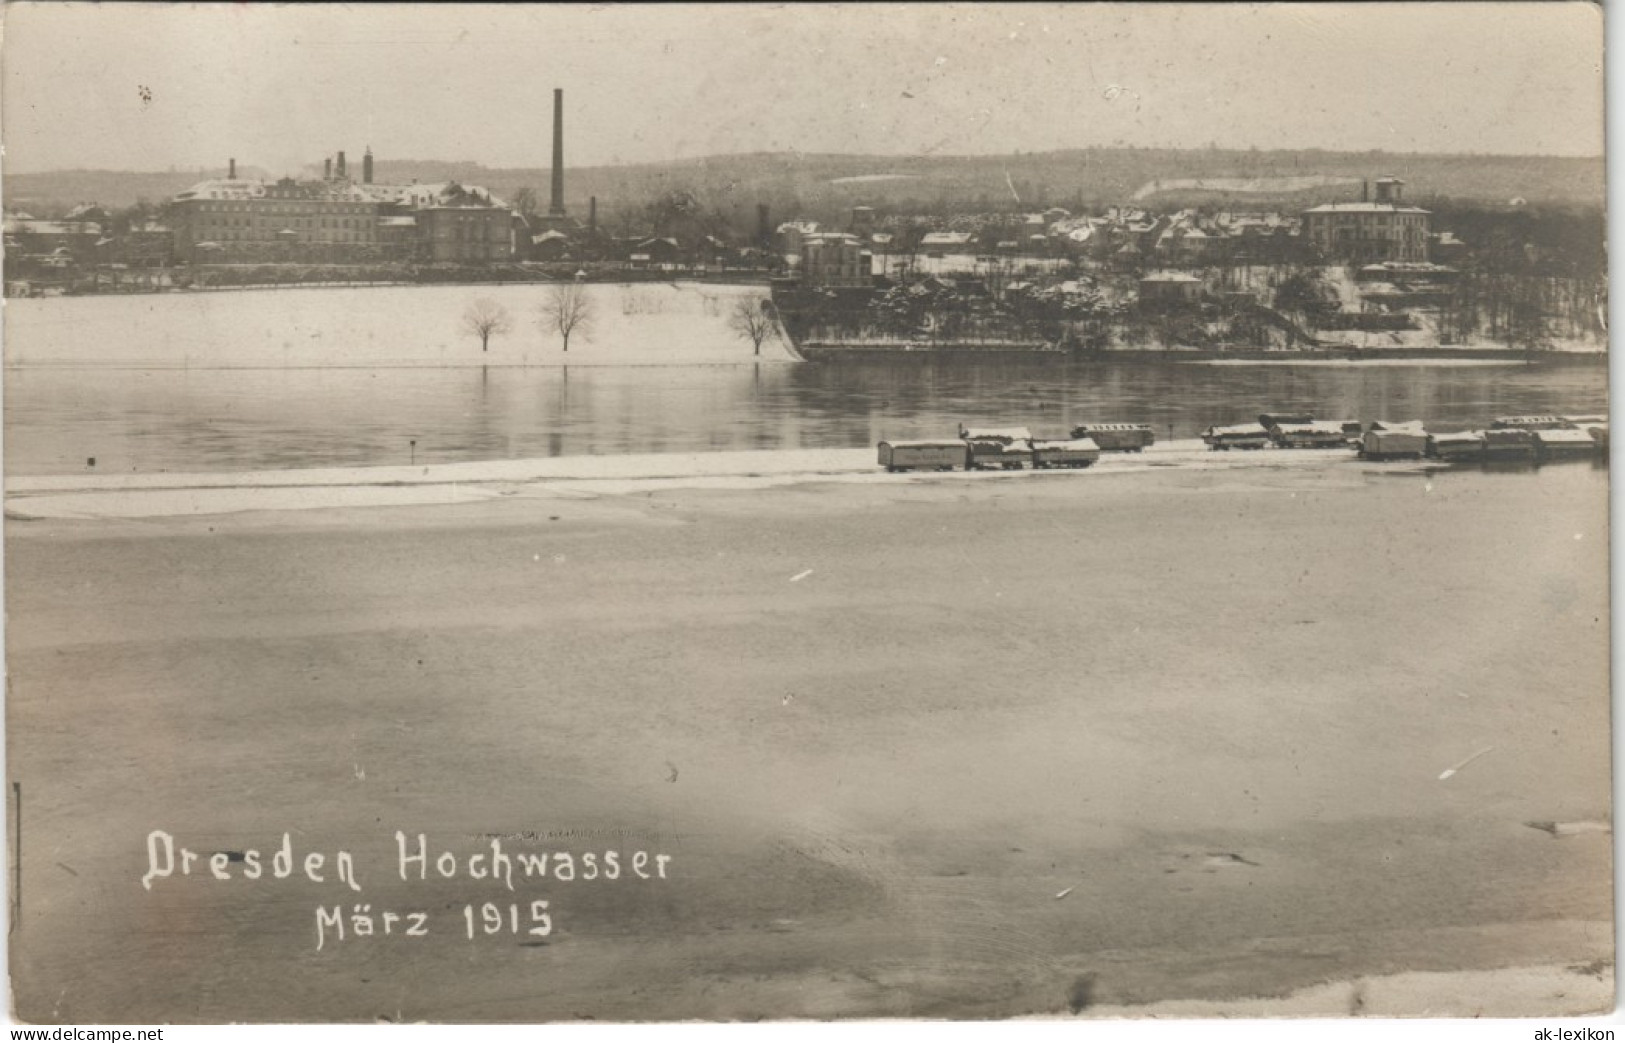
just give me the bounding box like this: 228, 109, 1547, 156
5, 357, 1607, 474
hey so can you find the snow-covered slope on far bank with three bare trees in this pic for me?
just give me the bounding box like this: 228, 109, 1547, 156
5, 283, 793, 369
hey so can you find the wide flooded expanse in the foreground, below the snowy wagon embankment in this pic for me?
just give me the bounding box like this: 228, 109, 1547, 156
7, 463, 1614, 1022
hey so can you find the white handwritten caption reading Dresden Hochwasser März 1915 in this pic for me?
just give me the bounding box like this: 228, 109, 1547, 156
141, 830, 671, 952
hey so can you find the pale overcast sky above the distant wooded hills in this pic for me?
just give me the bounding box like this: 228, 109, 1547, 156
0, 3, 1602, 172
